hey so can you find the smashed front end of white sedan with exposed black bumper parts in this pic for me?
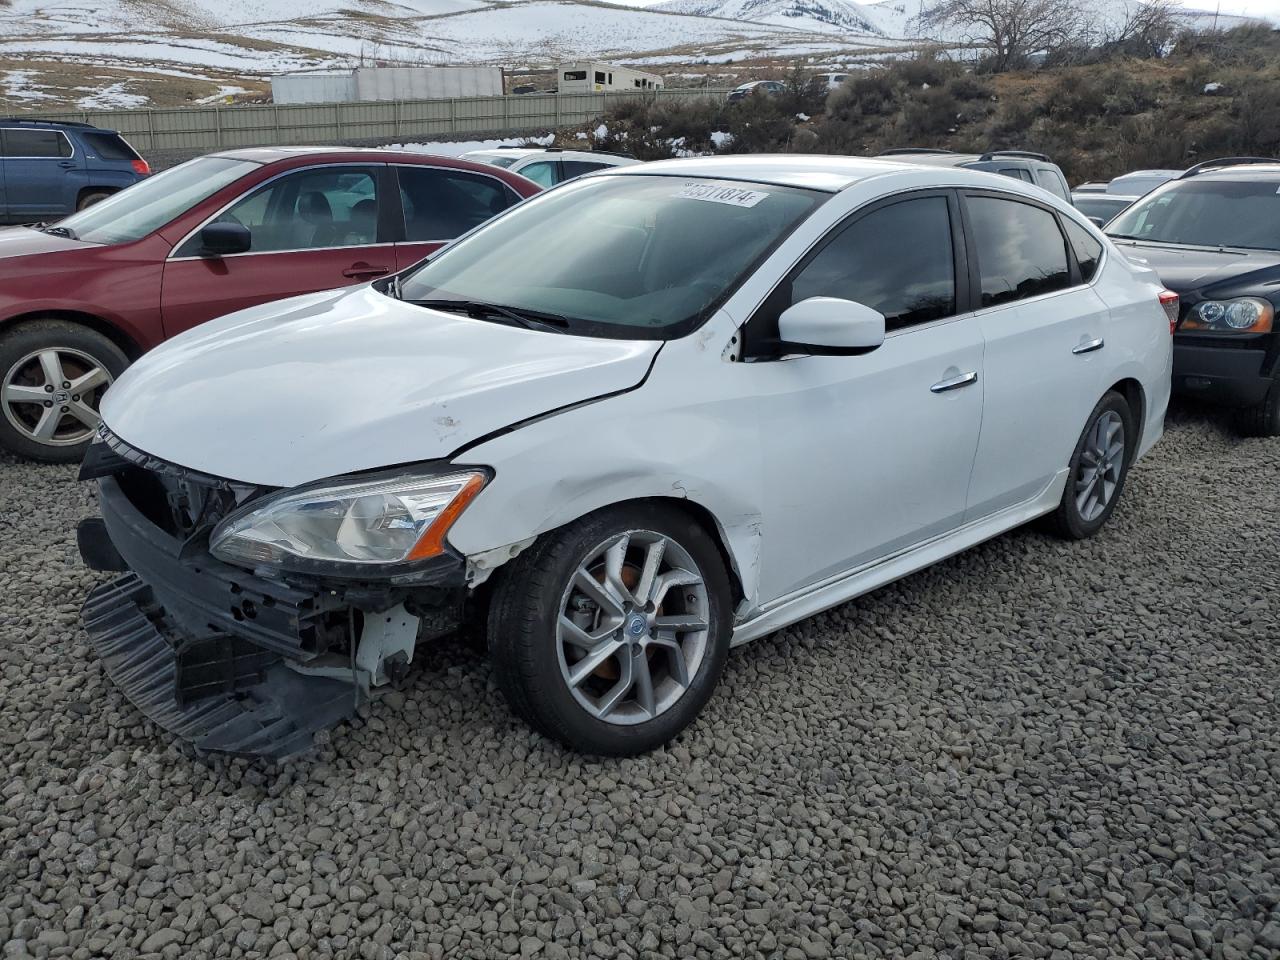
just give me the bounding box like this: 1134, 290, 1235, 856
78, 428, 467, 760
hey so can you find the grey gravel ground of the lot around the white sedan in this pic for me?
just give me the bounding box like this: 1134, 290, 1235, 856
0, 401, 1280, 960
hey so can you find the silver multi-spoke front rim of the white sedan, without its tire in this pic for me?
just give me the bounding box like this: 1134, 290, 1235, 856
556, 530, 709, 724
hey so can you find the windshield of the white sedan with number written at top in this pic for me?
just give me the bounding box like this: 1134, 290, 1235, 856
399, 175, 826, 339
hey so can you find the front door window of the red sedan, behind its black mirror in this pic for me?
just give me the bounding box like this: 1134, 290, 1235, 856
178, 166, 378, 256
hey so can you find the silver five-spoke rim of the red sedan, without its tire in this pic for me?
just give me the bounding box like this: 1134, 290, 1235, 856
0, 347, 113, 447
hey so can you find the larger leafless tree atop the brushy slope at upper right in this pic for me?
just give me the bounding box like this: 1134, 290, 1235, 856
922, 0, 1093, 72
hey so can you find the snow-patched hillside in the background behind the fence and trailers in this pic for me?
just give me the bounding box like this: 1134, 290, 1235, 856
0, 0, 1259, 111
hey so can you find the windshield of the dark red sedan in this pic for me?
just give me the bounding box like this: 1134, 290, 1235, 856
54, 156, 259, 243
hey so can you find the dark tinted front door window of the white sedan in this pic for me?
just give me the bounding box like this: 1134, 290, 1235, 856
790, 197, 956, 330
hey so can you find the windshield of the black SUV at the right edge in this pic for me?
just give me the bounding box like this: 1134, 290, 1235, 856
1107, 179, 1280, 250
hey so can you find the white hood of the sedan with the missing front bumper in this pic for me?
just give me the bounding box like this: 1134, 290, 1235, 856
102, 287, 662, 486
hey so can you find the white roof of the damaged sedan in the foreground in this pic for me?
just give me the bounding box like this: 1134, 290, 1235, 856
604, 154, 1075, 200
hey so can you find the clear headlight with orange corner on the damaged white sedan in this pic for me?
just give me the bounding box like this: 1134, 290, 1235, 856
209, 471, 486, 564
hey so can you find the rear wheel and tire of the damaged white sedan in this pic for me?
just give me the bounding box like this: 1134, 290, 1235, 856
1047, 390, 1138, 540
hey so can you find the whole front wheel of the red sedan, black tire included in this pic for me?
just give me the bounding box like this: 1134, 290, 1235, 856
0, 320, 129, 463
